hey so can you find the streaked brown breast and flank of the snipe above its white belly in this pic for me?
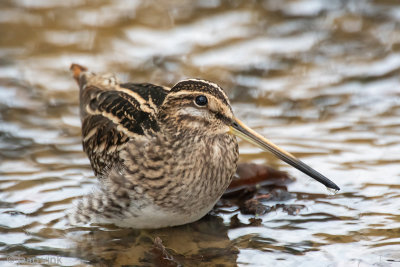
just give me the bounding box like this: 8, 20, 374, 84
125, 134, 238, 217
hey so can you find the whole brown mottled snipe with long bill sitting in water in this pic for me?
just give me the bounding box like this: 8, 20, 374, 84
70, 64, 339, 228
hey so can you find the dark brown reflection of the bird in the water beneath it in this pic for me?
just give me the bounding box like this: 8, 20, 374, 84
70, 215, 238, 266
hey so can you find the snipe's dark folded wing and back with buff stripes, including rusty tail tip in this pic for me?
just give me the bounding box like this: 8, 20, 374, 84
71, 65, 168, 177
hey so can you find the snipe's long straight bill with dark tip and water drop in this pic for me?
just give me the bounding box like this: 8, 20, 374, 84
230, 118, 340, 190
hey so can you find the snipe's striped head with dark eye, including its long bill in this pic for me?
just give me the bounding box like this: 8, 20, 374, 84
160, 79, 339, 190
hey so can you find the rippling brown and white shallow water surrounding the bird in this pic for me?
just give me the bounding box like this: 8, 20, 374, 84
0, 0, 400, 266
